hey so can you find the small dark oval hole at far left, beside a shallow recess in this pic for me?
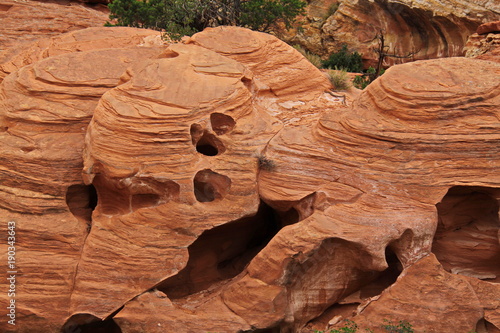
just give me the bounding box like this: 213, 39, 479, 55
66, 184, 97, 222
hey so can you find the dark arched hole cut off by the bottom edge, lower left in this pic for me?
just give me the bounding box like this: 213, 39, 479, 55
61, 313, 122, 333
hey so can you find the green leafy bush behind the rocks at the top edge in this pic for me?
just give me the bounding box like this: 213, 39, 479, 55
108, 0, 306, 36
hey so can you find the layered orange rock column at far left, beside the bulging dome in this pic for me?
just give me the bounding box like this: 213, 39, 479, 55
0, 28, 166, 332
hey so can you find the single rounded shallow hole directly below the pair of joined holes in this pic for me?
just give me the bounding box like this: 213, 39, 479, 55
193, 169, 231, 202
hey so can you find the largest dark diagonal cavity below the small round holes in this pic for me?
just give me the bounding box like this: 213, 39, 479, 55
156, 202, 281, 299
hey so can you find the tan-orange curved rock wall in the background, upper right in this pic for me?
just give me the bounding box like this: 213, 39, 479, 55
288, 0, 500, 68
